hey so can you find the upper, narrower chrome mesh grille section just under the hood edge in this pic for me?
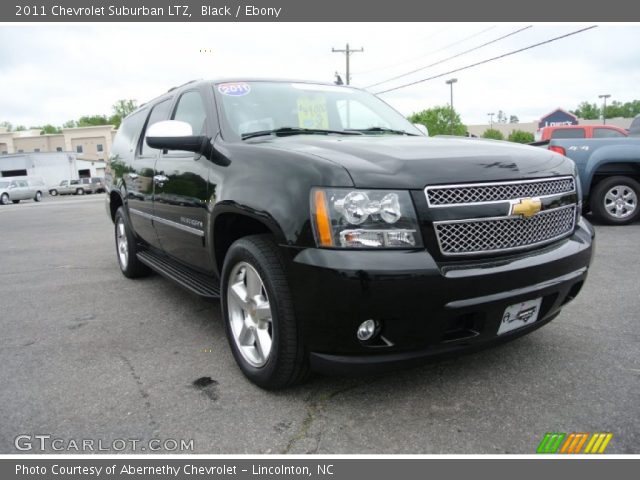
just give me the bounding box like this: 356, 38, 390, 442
425, 177, 576, 207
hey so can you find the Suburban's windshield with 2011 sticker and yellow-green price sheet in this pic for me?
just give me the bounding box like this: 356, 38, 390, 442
215, 82, 421, 140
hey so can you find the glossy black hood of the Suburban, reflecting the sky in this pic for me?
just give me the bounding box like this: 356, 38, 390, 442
248, 135, 574, 189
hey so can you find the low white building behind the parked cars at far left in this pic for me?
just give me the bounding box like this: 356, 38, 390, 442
0, 152, 106, 186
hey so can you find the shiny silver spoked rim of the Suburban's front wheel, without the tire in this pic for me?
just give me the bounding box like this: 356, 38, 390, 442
227, 262, 273, 367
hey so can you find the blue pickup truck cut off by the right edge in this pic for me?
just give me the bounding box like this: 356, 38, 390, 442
547, 137, 640, 225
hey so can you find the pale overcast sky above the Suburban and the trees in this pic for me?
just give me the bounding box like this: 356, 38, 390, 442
0, 23, 640, 126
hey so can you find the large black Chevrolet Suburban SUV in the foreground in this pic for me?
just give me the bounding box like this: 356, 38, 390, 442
106, 79, 594, 388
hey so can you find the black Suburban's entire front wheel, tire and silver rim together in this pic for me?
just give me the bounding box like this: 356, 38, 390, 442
221, 235, 309, 390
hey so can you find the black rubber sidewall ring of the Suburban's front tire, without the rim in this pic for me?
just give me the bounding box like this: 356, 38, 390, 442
220, 239, 282, 387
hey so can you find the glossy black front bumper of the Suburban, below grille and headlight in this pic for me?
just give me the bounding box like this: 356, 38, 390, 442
285, 219, 594, 373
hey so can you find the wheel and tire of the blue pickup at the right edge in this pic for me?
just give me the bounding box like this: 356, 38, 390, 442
589, 176, 640, 225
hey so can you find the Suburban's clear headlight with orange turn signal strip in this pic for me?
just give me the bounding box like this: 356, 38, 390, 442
311, 188, 422, 248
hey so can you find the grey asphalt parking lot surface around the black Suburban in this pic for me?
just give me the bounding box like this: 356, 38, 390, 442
0, 195, 640, 454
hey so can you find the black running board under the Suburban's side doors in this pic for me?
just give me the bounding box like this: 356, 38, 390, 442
137, 247, 220, 300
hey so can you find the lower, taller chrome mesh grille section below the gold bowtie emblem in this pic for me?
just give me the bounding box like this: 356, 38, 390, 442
434, 204, 576, 255
